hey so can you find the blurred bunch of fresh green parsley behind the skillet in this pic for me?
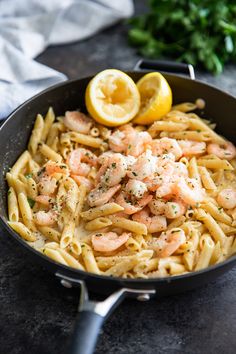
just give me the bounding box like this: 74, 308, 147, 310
129, 0, 236, 74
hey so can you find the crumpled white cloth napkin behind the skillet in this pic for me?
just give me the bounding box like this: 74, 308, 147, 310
0, 0, 133, 119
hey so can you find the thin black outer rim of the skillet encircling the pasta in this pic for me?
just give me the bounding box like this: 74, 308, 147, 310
0, 70, 236, 286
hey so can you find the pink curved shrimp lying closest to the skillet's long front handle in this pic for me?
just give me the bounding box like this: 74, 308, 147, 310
91, 232, 131, 252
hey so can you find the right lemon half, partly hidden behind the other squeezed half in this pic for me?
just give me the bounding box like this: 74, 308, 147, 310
133, 72, 172, 124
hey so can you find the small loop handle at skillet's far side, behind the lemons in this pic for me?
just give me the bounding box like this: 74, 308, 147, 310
134, 59, 195, 80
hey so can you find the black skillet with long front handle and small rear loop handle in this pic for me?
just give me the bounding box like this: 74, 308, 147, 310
0, 61, 236, 354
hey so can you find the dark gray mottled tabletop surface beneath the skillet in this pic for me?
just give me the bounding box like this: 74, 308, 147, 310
0, 2, 236, 354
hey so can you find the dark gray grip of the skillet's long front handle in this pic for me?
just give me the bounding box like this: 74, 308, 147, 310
68, 311, 105, 354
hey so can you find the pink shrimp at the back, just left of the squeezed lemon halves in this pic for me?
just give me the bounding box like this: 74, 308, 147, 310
63, 111, 92, 134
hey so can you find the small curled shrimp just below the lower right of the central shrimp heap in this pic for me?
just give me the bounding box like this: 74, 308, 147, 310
148, 199, 186, 219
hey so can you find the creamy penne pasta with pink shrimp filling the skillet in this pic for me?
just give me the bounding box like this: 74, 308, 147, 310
6, 98, 236, 279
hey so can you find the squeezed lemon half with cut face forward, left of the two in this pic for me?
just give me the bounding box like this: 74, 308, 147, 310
85, 69, 140, 127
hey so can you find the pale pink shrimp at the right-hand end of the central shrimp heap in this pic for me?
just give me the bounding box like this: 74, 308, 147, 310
173, 177, 205, 206
